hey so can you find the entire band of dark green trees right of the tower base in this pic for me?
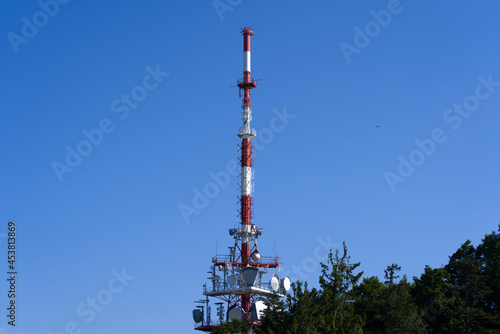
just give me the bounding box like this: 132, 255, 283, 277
250, 225, 500, 334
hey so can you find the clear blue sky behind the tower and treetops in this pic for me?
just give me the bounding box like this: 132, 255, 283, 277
0, 0, 500, 334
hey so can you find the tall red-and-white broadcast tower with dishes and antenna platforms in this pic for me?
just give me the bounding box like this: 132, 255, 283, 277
193, 28, 290, 333
